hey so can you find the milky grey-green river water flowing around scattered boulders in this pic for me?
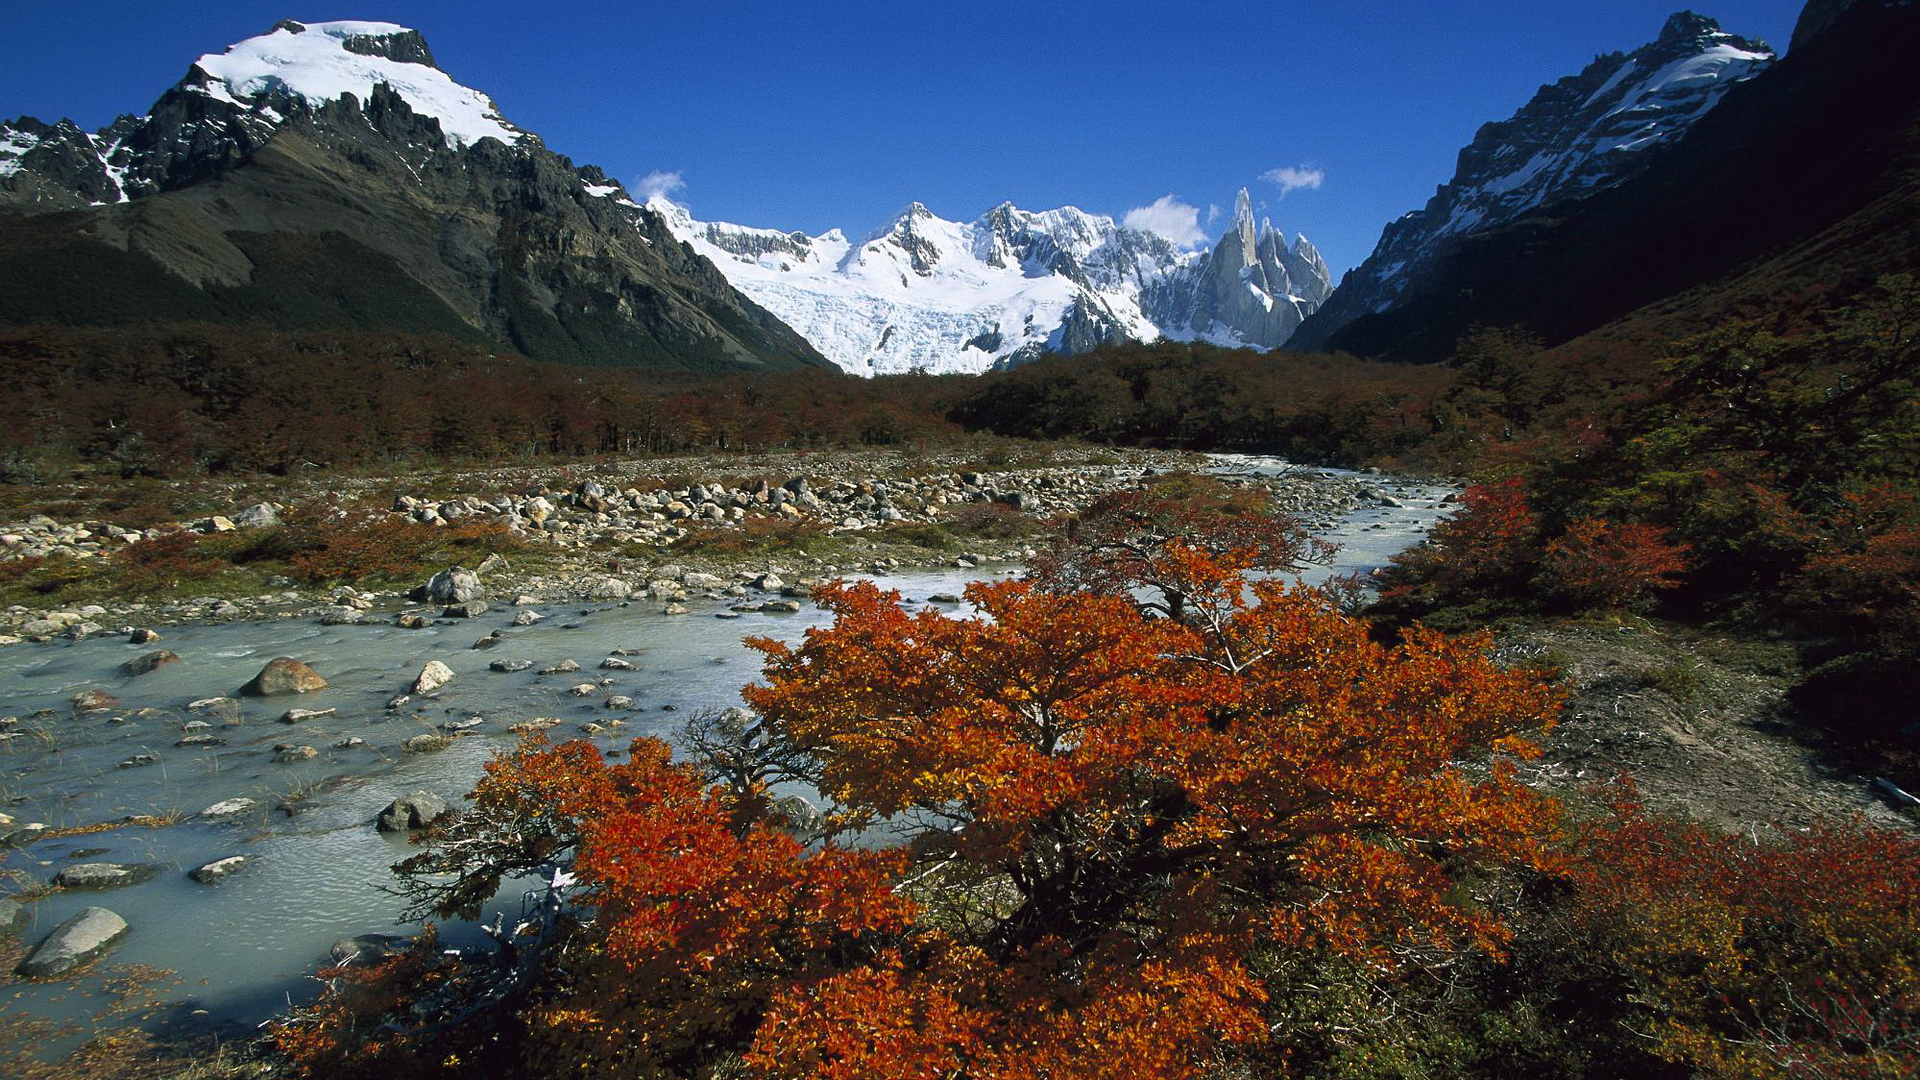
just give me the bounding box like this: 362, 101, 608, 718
0, 457, 1446, 1030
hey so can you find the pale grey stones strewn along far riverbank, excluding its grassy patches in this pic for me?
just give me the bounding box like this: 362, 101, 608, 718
0, 450, 1407, 644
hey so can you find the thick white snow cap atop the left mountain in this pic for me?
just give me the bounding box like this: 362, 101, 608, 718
194, 21, 524, 146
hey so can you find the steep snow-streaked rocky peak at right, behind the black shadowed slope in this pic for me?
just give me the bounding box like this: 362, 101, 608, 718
1292, 12, 1774, 348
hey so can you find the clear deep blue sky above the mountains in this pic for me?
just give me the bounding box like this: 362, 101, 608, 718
0, 0, 1801, 273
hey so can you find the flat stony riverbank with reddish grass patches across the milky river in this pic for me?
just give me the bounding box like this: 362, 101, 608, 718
0, 448, 1396, 644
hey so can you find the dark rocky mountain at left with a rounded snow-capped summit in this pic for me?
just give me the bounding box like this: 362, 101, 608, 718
0, 21, 824, 367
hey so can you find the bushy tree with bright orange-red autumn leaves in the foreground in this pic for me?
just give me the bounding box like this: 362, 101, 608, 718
295, 542, 1557, 1080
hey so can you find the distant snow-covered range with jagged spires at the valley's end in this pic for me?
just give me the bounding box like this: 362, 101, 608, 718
647, 192, 1331, 375
